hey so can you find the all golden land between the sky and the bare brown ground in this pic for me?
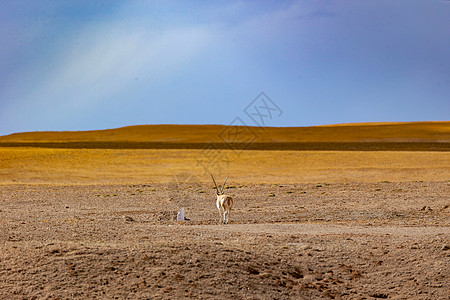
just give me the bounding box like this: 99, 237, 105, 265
0, 122, 450, 184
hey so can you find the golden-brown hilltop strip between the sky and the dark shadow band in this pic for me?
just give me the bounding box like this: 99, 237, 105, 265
0, 121, 450, 143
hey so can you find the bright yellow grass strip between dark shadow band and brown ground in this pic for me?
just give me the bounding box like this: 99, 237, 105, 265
0, 148, 450, 184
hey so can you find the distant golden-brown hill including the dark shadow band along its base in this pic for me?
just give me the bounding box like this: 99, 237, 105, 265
0, 121, 450, 151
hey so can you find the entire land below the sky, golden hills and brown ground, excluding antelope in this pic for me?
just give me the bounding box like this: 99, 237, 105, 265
0, 122, 450, 299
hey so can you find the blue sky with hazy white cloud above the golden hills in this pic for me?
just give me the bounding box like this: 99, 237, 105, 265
0, 0, 450, 135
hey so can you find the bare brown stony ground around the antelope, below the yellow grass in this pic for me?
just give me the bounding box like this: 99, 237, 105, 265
0, 180, 450, 299
